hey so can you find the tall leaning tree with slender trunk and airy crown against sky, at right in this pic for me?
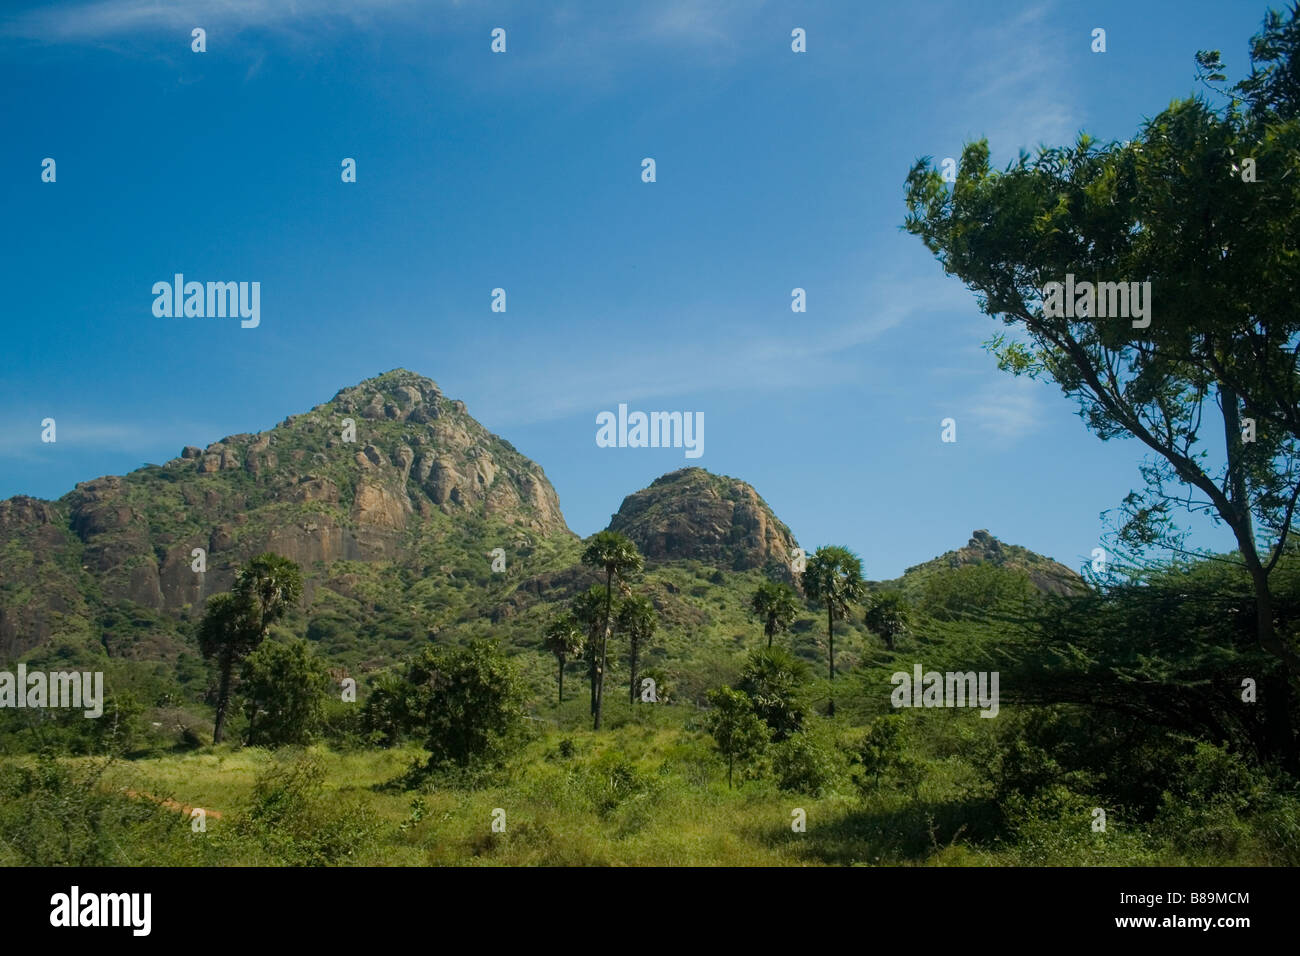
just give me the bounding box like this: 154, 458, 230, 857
906, 7, 1300, 697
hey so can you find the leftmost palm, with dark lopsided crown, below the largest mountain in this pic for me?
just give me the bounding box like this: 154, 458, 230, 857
199, 551, 303, 744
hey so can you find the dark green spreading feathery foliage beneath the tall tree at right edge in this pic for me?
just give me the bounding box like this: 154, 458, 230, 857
992, 557, 1300, 775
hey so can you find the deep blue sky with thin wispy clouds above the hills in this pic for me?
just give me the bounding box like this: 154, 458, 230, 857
0, 0, 1265, 578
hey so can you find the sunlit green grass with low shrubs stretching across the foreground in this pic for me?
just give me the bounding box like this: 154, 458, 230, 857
0, 695, 1295, 866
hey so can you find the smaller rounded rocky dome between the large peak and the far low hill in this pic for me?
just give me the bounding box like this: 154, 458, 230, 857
610, 468, 798, 575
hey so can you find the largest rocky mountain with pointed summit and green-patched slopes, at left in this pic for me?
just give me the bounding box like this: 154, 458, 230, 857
0, 369, 572, 639
